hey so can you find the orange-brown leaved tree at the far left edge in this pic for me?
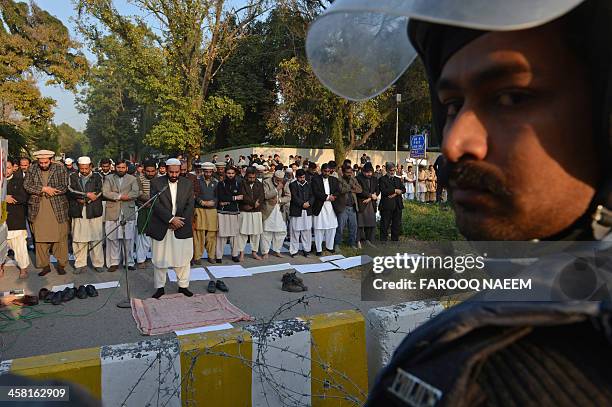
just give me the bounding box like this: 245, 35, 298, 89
0, 0, 88, 152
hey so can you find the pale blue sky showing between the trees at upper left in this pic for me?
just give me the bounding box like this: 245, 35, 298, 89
35, 0, 146, 131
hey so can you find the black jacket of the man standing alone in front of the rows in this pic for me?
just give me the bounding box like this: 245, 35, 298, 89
147, 175, 194, 241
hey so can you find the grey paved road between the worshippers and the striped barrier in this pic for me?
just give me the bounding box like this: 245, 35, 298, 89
0, 247, 400, 360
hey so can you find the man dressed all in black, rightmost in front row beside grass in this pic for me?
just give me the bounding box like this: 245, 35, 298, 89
378, 163, 406, 242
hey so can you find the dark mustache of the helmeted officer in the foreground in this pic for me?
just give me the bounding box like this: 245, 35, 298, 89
441, 161, 512, 197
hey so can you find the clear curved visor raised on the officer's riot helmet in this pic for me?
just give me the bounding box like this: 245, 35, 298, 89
306, 0, 584, 101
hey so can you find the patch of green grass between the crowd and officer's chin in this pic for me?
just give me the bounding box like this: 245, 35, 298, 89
402, 201, 464, 241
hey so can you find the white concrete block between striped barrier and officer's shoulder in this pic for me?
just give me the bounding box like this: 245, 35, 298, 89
366, 301, 446, 385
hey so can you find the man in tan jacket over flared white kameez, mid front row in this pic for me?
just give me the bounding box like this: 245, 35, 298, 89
261, 170, 291, 259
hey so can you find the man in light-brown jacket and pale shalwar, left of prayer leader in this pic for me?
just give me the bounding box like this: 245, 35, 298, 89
102, 159, 140, 273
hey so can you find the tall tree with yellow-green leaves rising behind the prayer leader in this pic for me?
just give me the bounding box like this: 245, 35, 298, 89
78, 0, 268, 153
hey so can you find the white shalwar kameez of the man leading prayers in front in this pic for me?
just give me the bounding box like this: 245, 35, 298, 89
151, 182, 193, 288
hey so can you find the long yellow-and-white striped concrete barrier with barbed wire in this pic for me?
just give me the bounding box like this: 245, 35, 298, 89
0, 311, 368, 407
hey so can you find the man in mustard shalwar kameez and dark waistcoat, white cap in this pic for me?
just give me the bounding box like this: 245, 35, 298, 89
193, 162, 219, 264
